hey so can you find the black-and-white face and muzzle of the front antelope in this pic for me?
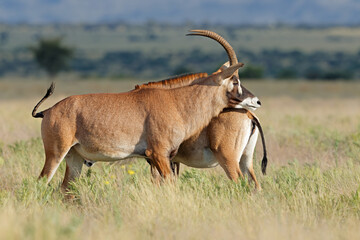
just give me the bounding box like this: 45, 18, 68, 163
228, 76, 261, 111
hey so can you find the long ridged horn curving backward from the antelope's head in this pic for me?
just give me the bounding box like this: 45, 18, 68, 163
186, 30, 239, 76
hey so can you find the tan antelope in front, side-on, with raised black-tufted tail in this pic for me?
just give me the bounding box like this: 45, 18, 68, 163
32, 31, 256, 189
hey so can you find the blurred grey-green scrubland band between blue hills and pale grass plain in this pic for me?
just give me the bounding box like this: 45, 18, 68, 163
0, 23, 360, 80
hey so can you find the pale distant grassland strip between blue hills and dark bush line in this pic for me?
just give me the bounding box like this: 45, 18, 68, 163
0, 23, 360, 54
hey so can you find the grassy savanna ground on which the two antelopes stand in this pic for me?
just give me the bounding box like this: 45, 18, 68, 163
0, 78, 360, 239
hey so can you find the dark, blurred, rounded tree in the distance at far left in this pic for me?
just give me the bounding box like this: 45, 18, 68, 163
30, 38, 73, 77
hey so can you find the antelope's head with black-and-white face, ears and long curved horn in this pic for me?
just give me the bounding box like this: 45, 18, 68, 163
187, 30, 261, 111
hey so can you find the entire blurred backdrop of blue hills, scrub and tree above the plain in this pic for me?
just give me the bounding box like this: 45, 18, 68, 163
0, 0, 360, 81
